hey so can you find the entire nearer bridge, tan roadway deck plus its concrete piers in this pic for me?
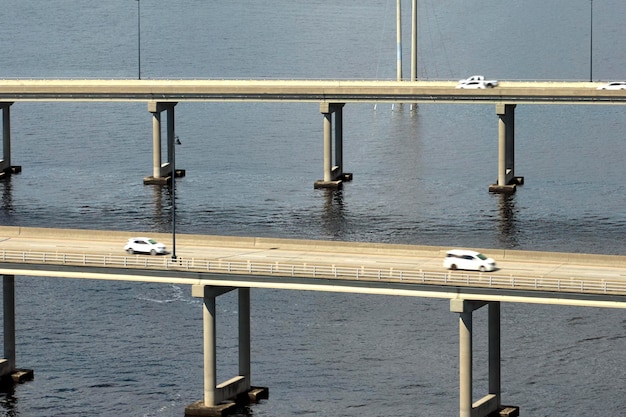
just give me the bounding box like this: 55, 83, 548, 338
0, 227, 626, 417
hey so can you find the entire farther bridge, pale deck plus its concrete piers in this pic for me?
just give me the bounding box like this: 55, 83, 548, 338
0, 79, 626, 193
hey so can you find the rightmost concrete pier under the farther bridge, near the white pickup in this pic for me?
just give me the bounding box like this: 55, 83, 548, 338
489, 103, 524, 193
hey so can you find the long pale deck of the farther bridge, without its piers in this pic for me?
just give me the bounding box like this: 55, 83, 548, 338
0, 79, 626, 104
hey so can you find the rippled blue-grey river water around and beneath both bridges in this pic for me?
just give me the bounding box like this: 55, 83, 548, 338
0, 0, 626, 417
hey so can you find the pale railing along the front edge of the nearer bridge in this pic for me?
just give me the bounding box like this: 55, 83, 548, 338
0, 250, 626, 295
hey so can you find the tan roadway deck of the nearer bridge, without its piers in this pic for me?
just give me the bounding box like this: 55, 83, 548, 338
0, 227, 626, 308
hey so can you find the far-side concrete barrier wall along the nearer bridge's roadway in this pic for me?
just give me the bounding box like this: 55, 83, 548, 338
0, 226, 626, 268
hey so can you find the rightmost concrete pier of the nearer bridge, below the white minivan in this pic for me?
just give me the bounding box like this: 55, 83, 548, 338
450, 299, 519, 417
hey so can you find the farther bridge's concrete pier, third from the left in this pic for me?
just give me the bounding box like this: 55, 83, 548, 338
313, 103, 352, 189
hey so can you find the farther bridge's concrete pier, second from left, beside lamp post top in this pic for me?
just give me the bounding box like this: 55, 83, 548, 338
143, 101, 185, 184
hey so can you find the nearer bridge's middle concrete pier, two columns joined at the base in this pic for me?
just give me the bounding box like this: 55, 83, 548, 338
185, 285, 269, 417
